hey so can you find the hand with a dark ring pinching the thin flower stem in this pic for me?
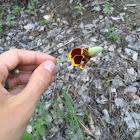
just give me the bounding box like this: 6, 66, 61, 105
0, 49, 55, 140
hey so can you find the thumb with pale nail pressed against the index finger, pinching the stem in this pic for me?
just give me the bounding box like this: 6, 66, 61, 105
20, 60, 55, 102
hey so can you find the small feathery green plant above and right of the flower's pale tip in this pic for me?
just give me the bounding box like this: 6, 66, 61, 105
101, 26, 120, 41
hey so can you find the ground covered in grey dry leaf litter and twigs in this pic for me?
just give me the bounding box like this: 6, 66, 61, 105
0, 0, 140, 140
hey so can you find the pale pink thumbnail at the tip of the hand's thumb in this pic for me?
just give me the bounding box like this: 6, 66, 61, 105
44, 60, 55, 74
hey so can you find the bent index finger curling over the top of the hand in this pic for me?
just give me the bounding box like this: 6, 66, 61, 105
0, 49, 56, 82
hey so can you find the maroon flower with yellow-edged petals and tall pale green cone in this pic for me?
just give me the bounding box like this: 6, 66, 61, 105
69, 47, 102, 69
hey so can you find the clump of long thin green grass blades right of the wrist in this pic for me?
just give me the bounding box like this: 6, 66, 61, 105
55, 90, 85, 140
